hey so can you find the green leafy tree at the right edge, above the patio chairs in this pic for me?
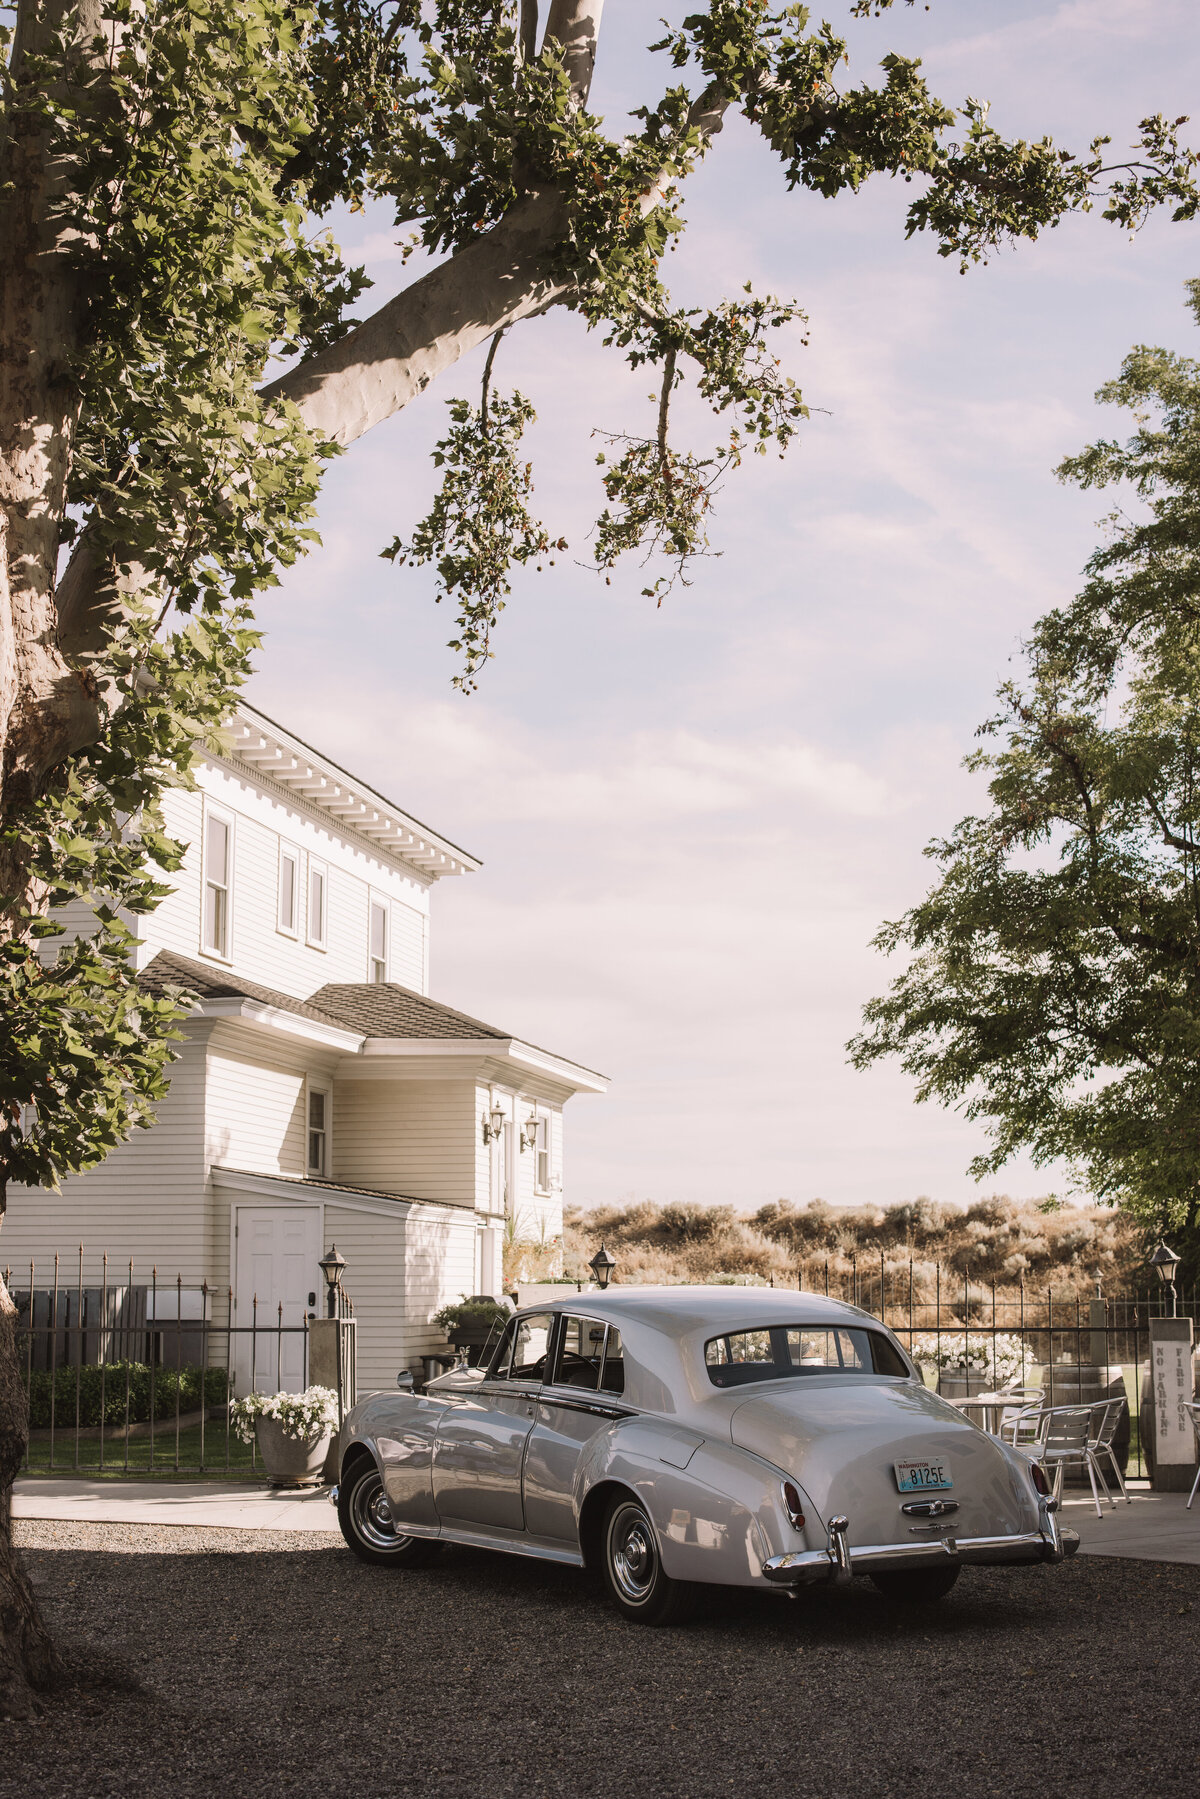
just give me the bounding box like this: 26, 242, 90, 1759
851, 282, 1200, 1272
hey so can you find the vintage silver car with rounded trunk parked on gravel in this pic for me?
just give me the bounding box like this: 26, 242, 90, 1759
335, 1286, 1078, 1624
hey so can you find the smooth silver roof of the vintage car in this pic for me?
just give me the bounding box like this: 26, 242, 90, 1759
522, 1286, 876, 1337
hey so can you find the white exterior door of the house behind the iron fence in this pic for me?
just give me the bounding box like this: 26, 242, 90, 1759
230, 1205, 324, 1394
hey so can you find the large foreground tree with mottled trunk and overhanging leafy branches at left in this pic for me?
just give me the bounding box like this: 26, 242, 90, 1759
0, 0, 1196, 1711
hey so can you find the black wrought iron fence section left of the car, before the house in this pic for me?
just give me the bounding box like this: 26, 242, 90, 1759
4, 1249, 354, 1477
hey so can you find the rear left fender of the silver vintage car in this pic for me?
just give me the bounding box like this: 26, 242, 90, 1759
576, 1418, 806, 1587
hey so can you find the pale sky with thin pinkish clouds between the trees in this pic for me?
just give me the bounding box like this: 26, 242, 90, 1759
248, 0, 1200, 1207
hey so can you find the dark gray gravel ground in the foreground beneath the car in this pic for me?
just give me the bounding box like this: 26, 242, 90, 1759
9, 1524, 1200, 1799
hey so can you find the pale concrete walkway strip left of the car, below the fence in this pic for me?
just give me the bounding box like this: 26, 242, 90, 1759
13, 1477, 340, 1536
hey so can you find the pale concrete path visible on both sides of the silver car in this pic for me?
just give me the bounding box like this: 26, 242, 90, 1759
13, 1479, 1200, 1565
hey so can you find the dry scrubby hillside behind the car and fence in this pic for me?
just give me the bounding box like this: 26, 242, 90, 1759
563, 1196, 1144, 1304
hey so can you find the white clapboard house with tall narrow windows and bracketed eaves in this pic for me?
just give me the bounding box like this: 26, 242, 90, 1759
4, 705, 604, 1391
